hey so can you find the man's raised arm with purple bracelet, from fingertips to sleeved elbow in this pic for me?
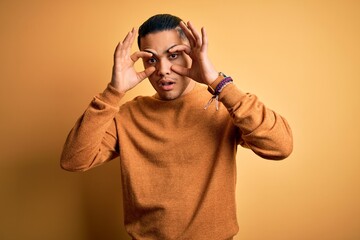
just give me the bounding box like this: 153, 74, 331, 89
171, 22, 293, 159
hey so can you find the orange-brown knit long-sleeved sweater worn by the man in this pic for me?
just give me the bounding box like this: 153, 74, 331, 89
61, 84, 292, 240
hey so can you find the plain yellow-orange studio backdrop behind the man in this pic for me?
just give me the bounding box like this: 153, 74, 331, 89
0, 0, 360, 240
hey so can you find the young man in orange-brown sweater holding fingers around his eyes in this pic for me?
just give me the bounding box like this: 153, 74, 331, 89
61, 14, 292, 240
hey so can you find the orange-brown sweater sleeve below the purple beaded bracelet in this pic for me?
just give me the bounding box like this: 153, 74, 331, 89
219, 84, 293, 160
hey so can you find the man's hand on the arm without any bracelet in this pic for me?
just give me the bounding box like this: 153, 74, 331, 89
110, 28, 155, 93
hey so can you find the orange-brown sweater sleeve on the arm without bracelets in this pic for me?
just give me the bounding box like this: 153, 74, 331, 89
60, 85, 123, 171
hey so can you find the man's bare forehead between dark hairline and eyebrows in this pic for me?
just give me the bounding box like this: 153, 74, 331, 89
140, 29, 183, 52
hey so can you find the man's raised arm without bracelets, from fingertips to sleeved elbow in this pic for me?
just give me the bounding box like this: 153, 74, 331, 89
60, 29, 155, 171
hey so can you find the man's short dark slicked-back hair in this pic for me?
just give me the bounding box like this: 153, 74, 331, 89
137, 14, 185, 48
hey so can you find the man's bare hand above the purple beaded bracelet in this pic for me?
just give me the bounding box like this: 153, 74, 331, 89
169, 22, 218, 85
